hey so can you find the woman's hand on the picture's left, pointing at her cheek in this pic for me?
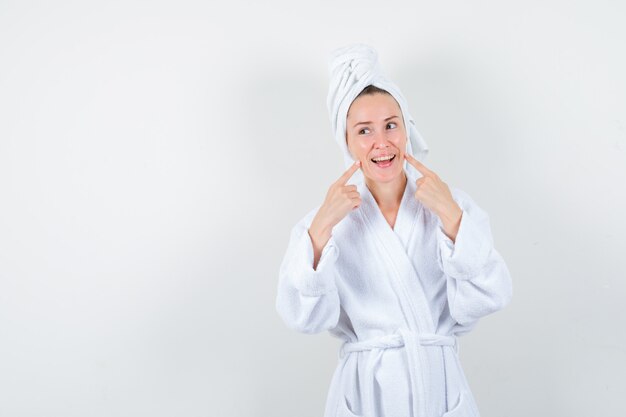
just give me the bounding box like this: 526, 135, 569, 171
309, 161, 361, 268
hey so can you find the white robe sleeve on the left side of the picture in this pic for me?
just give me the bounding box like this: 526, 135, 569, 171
276, 216, 340, 333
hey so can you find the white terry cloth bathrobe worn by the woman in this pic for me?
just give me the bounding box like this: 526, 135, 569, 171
276, 171, 512, 417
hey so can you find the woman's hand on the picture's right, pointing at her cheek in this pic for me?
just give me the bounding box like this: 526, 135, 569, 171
404, 153, 463, 241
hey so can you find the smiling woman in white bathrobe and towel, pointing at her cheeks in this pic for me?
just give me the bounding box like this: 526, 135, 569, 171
276, 45, 512, 417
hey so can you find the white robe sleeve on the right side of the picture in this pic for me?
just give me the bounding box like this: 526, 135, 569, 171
437, 187, 513, 329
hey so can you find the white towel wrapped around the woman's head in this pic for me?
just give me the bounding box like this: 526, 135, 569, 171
327, 43, 428, 180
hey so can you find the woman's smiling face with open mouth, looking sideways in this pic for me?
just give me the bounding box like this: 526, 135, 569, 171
346, 93, 406, 182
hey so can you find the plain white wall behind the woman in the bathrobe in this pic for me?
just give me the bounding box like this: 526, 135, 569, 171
0, 0, 626, 417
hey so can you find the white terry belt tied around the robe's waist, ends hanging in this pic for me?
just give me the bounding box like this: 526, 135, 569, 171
339, 329, 459, 417
